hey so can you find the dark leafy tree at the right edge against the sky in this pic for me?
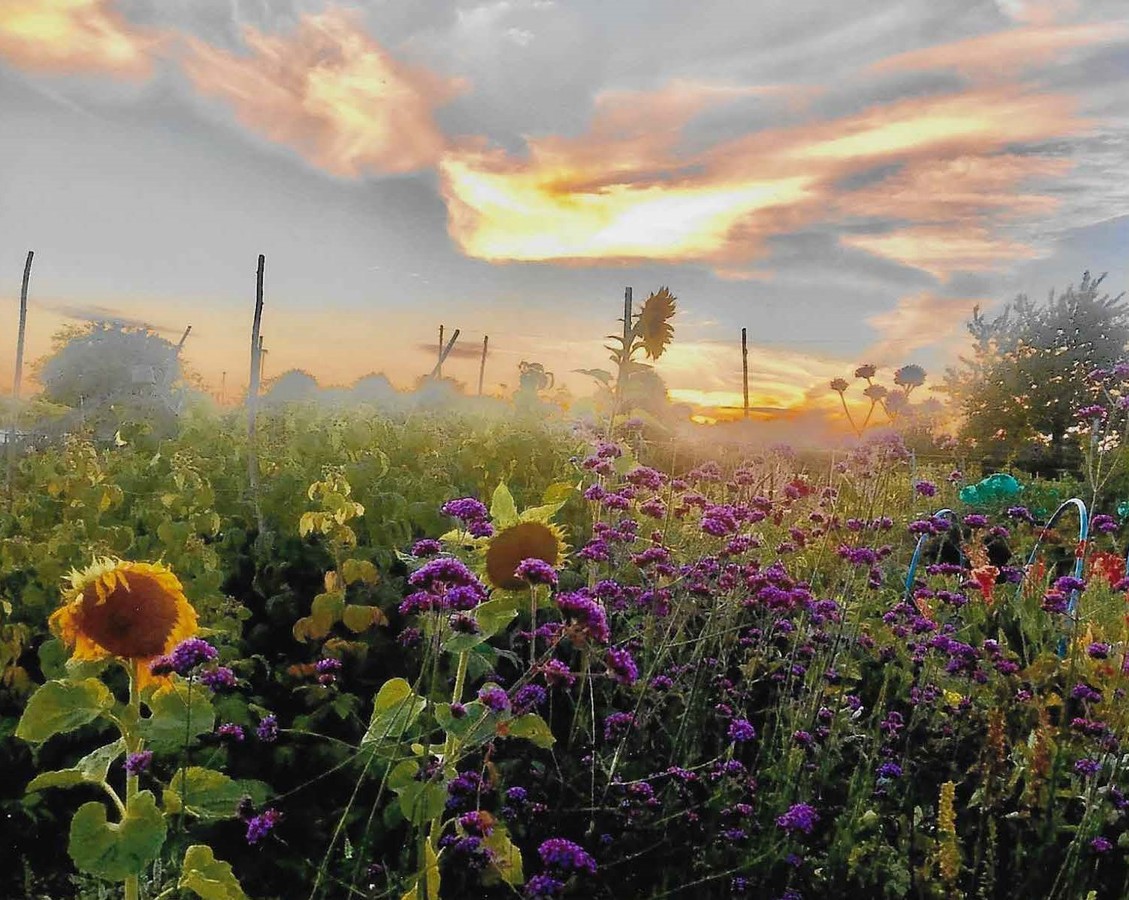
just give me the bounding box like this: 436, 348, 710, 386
945, 272, 1129, 472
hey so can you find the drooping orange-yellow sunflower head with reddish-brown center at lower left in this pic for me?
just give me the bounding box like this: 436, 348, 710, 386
51, 558, 196, 687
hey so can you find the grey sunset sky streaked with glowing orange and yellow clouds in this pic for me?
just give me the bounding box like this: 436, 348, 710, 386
0, 0, 1129, 417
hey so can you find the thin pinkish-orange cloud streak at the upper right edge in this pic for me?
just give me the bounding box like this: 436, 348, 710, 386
870, 23, 1129, 75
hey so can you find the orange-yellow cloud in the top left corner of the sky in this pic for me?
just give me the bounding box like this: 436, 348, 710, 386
0, 0, 160, 79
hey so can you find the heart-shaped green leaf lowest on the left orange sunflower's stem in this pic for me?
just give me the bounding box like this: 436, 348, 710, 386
67, 790, 166, 881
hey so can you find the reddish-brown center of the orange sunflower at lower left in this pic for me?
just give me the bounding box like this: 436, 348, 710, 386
79, 571, 178, 659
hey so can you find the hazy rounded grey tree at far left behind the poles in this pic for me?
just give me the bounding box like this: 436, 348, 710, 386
38, 322, 187, 438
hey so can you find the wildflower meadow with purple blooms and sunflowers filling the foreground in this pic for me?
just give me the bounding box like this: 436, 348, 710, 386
0, 285, 1129, 900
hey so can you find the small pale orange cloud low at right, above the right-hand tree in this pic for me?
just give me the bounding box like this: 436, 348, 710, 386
840, 225, 1040, 281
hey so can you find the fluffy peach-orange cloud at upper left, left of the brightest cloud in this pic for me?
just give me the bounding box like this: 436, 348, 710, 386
184, 9, 463, 177
